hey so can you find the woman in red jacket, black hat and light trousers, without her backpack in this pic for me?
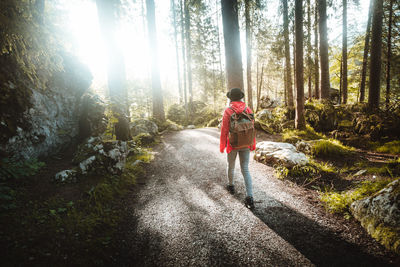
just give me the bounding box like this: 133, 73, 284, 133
219, 88, 256, 209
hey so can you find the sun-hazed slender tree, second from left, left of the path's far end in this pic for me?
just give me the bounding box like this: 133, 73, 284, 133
146, 0, 165, 121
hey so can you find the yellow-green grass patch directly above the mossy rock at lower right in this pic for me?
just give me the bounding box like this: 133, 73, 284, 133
320, 179, 393, 216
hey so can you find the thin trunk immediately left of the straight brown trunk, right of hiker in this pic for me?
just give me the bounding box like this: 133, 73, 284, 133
282, 0, 294, 107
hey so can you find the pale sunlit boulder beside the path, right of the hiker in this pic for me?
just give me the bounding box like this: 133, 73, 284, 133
254, 141, 308, 168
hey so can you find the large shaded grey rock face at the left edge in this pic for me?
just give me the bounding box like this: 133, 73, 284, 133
0, 55, 92, 160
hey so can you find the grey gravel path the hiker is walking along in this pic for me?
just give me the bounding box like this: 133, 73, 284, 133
116, 128, 387, 266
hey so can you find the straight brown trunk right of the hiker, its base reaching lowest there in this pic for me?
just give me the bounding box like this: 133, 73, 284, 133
295, 0, 306, 129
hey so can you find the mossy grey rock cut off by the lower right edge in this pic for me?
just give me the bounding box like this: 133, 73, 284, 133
350, 179, 400, 253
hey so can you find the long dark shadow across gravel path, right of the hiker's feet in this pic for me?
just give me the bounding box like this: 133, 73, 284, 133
248, 191, 388, 266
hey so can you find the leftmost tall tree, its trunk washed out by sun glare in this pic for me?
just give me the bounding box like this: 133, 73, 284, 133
96, 0, 130, 140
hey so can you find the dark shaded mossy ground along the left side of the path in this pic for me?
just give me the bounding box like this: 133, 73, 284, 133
0, 148, 152, 266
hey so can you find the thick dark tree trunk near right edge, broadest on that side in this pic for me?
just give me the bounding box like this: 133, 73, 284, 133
368, 0, 383, 110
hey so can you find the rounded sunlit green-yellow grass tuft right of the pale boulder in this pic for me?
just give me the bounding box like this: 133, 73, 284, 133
311, 139, 354, 157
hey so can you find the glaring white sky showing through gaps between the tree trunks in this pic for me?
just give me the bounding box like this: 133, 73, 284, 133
66, 0, 369, 96
